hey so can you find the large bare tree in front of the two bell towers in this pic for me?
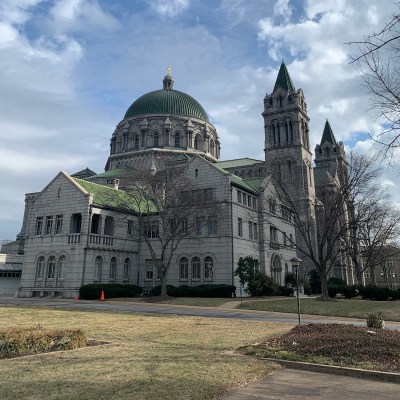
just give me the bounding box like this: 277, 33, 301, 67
263, 153, 380, 299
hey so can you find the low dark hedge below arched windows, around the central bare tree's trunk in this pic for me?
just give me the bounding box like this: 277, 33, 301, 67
150, 285, 236, 297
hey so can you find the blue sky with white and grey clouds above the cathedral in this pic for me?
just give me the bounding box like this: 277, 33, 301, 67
0, 0, 400, 240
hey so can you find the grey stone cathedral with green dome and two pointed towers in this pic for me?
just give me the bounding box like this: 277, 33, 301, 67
0, 63, 345, 298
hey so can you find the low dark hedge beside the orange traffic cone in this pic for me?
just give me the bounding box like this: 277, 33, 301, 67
79, 283, 142, 300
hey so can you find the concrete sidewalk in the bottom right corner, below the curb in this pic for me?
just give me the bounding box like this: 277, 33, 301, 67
219, 368, 400, 400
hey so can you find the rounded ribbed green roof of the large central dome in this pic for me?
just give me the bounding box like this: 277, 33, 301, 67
124, 89, 210, 122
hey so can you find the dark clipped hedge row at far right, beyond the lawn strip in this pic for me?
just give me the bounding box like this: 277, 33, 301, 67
328, 284, 400, 301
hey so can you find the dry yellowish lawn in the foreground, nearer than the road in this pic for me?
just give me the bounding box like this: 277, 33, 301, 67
0, 307, 291, 400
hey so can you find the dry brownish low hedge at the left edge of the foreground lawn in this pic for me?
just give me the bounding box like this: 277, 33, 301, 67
0, 327, 86, 358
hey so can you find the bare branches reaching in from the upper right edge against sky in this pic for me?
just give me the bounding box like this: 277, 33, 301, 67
348, 2, 400, 156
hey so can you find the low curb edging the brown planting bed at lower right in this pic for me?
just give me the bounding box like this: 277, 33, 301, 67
261, 358, 400, 383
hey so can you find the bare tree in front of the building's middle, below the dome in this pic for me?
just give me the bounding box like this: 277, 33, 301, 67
128, 158, 216, 296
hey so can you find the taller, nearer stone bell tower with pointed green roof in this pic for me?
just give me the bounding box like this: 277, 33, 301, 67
262, 62, 317, 271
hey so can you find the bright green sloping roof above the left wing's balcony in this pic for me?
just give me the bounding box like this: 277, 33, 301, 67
74, 178, 139, 212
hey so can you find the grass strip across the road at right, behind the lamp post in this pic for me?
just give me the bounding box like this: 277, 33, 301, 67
237, 297, 400, 321
